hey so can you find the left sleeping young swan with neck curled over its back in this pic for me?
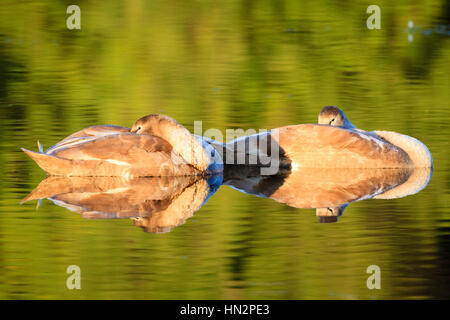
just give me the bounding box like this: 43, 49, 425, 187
22, 114, 222, 178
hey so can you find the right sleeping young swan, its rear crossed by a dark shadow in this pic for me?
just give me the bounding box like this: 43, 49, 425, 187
199, 107, 433, 170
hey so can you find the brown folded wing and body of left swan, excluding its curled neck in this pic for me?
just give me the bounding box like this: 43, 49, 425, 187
24, 133, 199, 178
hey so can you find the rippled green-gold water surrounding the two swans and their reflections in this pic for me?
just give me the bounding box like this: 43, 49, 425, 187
0, 1, 450, 299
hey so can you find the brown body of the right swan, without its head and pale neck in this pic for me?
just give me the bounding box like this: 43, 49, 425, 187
218, 124, 413, 171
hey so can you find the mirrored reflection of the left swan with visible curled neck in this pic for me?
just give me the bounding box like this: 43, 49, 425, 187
22, 176, 222, 233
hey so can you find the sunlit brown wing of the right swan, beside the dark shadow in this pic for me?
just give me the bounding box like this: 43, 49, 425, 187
271, 124, 412, 170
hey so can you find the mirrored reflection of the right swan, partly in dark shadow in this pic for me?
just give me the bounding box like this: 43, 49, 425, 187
224, 167, 432, 222
